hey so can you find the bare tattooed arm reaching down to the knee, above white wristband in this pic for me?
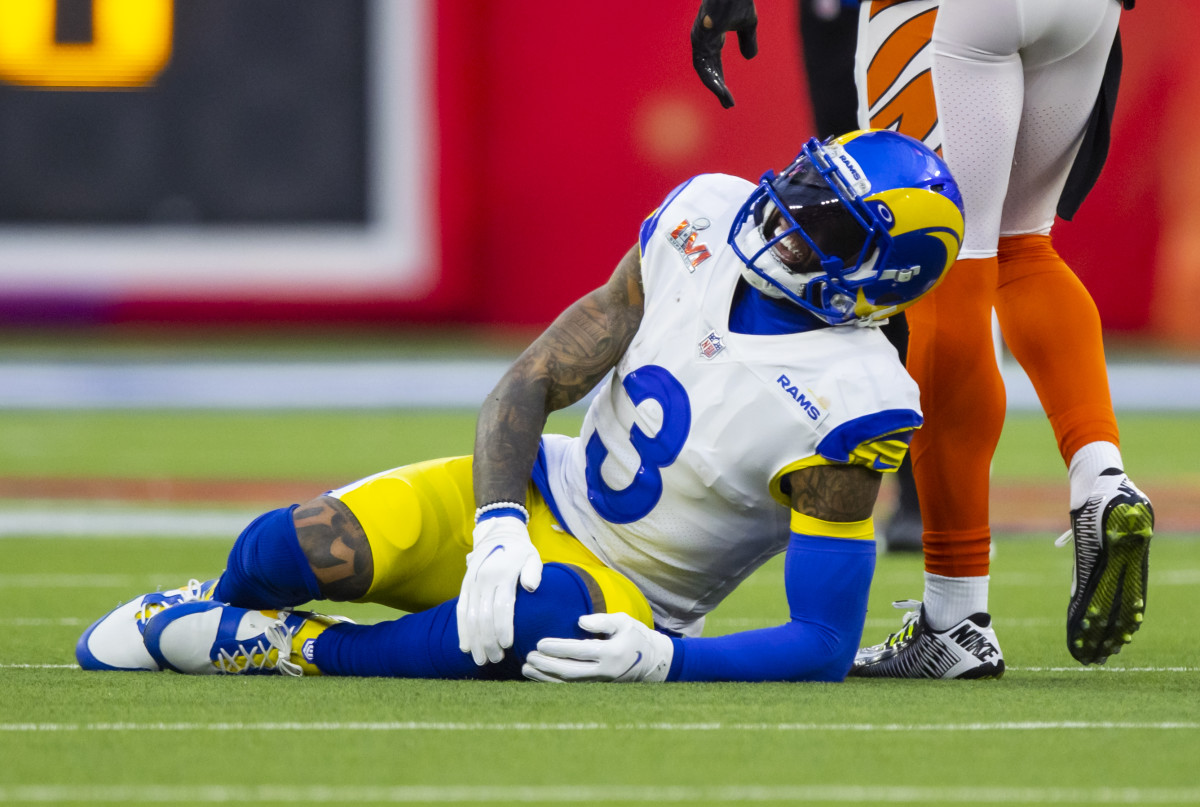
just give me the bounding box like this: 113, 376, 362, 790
474, 245, 642, 504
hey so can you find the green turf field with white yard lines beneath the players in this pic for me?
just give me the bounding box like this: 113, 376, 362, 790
0, 412, 1200, 805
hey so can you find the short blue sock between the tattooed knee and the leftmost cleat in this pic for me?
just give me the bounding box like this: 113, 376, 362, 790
212, 504, 320, 609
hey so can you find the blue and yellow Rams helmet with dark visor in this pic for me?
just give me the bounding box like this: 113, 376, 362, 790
728, 130, 962, 325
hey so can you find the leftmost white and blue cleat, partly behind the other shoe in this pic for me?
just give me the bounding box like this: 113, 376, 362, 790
76, 578, 220, 671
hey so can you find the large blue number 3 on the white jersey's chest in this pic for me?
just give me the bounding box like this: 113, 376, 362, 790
586, 364, 691, 524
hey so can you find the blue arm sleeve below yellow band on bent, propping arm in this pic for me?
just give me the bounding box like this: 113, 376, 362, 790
667, 533, 875, 681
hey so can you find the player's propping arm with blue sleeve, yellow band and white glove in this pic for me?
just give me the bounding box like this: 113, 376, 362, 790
523, 465, 881, 681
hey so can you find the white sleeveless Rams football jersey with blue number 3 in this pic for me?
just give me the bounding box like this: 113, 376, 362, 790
535, 174, 920, 635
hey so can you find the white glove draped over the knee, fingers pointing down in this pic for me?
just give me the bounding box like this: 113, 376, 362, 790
457, 515, 541, 666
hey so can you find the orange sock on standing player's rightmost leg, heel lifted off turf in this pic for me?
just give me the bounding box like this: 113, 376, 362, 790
996, 235, 1120, 464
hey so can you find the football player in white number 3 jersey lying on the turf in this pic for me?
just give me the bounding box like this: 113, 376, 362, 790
77, 131, 962, 681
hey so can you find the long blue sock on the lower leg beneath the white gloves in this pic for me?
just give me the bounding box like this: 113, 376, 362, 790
312, 563, 592, 679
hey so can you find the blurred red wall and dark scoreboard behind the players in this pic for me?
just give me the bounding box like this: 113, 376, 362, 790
0, 0, 1200, 349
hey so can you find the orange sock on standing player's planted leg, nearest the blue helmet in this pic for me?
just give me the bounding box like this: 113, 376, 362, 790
907, 258, 1004, 578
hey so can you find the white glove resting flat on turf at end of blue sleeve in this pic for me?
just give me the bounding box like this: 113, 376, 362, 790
521, 612, 674, 683
